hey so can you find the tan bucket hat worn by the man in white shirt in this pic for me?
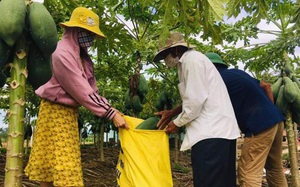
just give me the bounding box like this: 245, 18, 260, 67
153, 32, 196, 62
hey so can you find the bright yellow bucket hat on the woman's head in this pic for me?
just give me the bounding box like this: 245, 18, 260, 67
59, 7, 105, 38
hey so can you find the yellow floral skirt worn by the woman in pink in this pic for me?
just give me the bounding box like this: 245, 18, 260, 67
25, 100, 84, 186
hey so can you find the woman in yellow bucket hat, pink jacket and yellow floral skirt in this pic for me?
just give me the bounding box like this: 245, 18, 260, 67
25, 7, 128, 187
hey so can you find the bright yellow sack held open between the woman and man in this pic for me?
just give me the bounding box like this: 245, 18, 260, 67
117, 116, 173, 187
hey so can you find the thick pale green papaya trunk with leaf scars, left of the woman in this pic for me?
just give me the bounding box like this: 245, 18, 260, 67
4, 36, 28, 187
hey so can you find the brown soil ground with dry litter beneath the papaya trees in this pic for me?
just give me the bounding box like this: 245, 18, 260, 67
0, 138, 298, 187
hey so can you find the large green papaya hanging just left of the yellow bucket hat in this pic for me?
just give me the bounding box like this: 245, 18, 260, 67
28, 2, 58, 56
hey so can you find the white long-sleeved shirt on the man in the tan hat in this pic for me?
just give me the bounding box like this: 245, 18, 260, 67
174, 50, 240, 151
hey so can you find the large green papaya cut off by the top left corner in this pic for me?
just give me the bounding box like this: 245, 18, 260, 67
0, 0, 26, 47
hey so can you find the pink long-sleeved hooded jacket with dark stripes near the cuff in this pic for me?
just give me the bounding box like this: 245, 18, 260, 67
35, 28, 116, 119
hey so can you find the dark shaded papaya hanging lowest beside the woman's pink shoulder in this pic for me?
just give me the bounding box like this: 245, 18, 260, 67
27, 45, 52, 89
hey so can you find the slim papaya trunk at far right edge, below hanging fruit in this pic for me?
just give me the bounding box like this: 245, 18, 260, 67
285, 110, 300, 187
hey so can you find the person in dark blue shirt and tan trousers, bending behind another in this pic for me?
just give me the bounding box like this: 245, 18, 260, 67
205, 52, 287, 187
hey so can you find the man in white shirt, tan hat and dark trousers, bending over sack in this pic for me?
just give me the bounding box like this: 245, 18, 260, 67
153, 33, 240, 187
